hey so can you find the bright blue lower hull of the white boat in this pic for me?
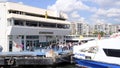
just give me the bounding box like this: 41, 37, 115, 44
74, 58, 120, 68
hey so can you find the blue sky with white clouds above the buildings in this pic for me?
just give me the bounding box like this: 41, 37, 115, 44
0, 0, 120, 24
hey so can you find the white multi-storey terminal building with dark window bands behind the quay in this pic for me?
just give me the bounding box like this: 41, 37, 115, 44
0, 2, 70, 52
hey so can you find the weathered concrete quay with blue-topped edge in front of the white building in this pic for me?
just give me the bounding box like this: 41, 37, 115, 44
0, 50, 72, 67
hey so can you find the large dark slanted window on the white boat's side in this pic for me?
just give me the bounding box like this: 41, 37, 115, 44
103, 49, 120, 57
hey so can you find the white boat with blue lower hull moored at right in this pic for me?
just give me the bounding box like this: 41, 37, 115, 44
73, 33, 120, 68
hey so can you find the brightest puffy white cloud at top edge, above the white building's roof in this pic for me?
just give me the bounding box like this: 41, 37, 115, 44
48, 0, 89, 12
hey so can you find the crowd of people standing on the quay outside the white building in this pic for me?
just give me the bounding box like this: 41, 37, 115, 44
27, 42, 86, 51
